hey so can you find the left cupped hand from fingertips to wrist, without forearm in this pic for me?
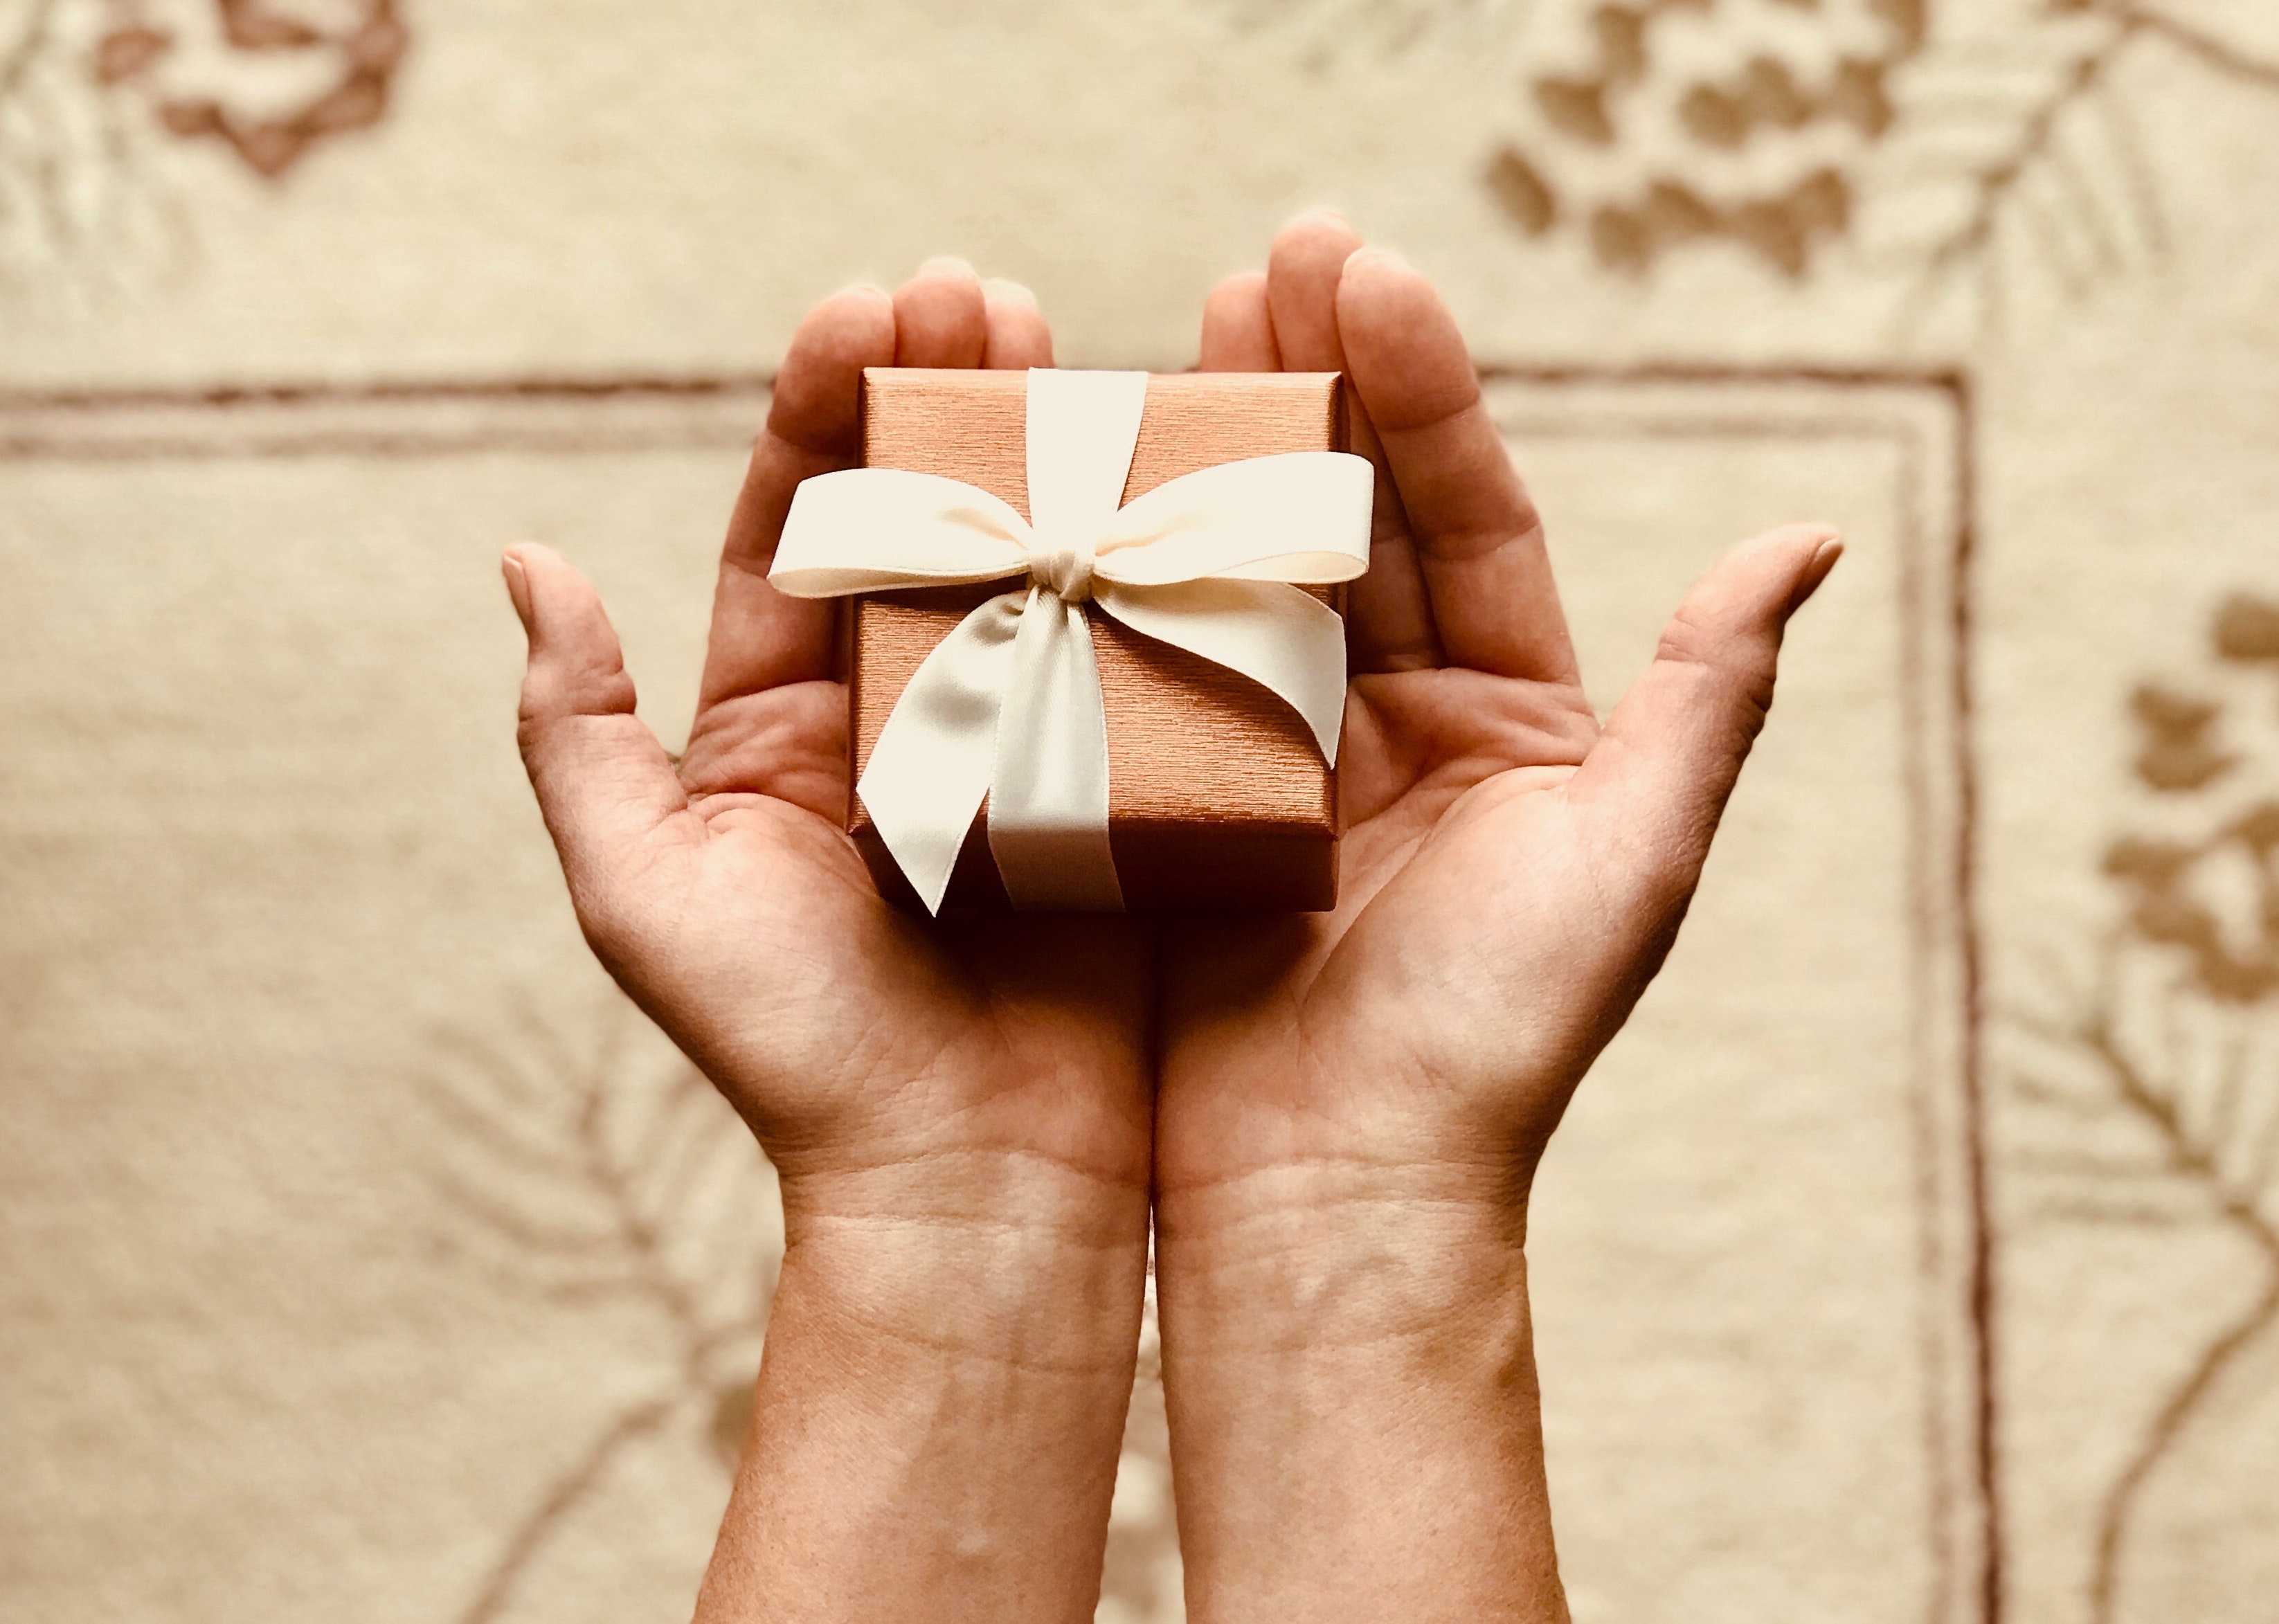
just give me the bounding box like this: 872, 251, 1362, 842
506, 260, 1153, 1223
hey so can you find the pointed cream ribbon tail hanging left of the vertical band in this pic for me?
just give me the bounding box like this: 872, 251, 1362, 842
855, 592, 1023, 913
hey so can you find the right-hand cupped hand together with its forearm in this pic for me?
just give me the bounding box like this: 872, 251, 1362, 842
1155, 214, 1839, 1624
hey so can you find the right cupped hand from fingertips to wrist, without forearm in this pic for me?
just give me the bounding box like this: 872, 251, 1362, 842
1155, 214, 1839, 1223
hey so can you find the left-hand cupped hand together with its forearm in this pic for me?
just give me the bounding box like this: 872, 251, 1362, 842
504, 260, 1155, 1624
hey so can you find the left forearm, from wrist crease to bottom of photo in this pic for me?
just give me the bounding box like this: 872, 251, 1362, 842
697, 1157, 1146, 1624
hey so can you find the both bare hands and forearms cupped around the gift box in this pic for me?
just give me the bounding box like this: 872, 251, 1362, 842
506, 217, 1837, 1622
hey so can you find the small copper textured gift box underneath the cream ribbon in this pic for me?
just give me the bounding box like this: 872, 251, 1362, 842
845, 367, 1347, 911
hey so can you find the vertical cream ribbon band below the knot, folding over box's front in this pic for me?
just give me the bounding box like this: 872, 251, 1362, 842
989, 588, 1124, 913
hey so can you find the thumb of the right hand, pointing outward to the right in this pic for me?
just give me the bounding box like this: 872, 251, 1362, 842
1568, 524, 1844, 913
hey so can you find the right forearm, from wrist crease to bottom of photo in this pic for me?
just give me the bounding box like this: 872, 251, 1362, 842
1155, 1169, 1566, 1624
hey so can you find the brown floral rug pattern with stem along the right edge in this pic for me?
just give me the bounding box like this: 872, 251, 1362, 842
2006, 595, 2279, 1624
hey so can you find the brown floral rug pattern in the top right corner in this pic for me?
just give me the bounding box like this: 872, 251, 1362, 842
1481, 0, 2279, 330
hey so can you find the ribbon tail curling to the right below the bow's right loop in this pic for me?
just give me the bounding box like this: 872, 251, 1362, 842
1094, 576, 1344, 766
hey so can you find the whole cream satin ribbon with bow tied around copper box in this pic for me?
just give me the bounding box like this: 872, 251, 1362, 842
768, 369, 1372, 913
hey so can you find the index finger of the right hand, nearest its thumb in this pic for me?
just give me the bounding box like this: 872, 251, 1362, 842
1337, 249, 1575, 683
